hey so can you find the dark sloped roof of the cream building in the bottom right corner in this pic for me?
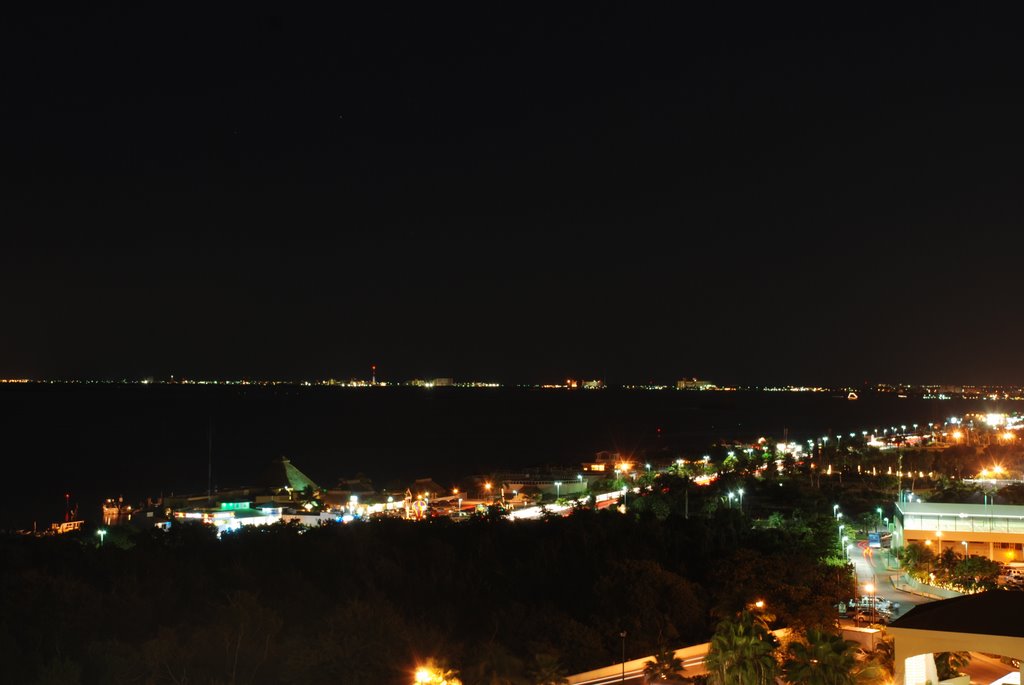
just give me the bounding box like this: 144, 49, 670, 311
890, 590, 1024, 638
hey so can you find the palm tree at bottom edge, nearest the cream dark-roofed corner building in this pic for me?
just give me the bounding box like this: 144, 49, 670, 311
782, 628, 885, 685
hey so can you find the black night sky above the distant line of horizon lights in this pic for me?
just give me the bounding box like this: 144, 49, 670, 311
0, 3, 1024, 383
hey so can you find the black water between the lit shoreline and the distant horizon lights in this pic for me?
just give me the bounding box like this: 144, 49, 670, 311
0, 385, 1018, 528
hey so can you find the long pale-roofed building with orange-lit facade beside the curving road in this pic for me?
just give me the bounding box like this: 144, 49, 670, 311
892, 502, 1024, 563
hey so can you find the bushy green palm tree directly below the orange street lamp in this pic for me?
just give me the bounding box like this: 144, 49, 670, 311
705, 611, 778, 685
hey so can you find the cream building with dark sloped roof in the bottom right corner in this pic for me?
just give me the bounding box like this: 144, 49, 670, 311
889, 591, 1024, 685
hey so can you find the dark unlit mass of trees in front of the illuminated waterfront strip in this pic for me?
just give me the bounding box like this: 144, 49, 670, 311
0, 481, 851, 685
